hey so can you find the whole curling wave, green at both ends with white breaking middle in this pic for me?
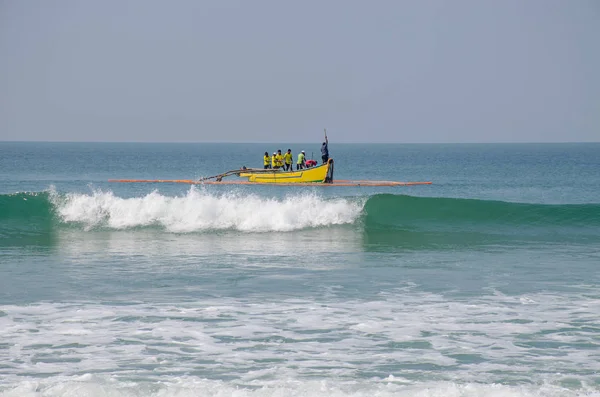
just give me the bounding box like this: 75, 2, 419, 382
0, 187, 600, 246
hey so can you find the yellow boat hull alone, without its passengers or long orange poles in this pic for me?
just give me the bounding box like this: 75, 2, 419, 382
238, 159, 333, 183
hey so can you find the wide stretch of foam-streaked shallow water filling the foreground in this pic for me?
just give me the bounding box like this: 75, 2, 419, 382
0, 286, 600, 397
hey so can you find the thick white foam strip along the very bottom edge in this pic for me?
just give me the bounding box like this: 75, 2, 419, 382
0, 375, 600, 397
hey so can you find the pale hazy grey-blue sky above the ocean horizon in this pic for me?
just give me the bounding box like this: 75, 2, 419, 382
0, 0, 600, 142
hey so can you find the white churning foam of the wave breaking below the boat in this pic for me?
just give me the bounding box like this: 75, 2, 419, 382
50, 187, 364, 233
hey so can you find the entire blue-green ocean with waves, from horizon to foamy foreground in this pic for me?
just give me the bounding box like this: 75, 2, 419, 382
0, 142, 600, 397
